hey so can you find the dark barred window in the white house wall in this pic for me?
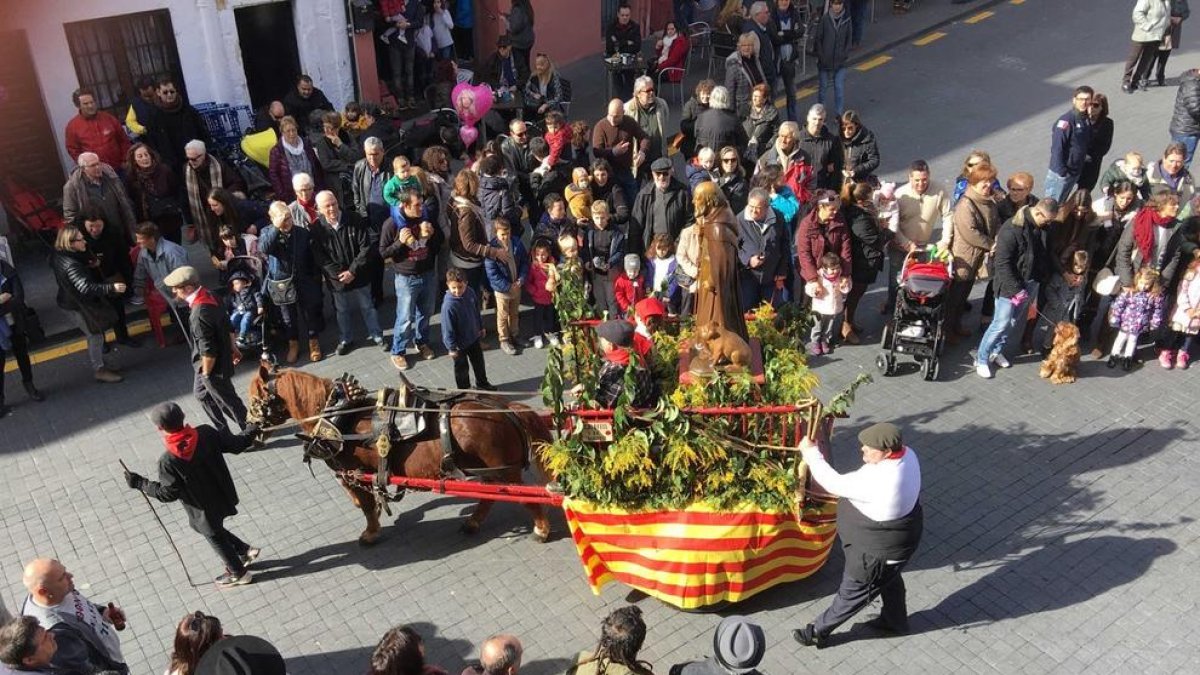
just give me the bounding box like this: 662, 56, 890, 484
64, 10, 185, 119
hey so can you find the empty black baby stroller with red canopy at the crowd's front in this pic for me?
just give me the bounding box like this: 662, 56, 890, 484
875, 249, 952, 382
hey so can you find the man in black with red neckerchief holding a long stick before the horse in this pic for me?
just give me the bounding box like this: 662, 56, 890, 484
125, 402, 260, 587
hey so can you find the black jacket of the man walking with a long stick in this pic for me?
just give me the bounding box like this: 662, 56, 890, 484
142, 424, 252, 536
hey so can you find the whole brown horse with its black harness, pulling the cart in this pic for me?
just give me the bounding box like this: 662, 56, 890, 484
250, 363, 552, 545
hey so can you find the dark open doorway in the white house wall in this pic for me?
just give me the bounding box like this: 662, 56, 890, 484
234, 2, 300, 109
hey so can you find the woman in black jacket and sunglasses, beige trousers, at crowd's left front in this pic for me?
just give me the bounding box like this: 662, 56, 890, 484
50, 225, 126, 383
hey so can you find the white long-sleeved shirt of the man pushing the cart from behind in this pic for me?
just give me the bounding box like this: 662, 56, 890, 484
804, 447, 920, 522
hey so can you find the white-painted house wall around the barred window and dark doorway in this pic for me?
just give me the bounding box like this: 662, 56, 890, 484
0, 0, 354, 176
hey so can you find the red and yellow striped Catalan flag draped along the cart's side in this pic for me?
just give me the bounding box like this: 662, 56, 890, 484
563, 498, 838, 609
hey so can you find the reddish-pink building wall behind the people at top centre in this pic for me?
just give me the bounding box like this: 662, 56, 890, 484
475, 0, 604, 66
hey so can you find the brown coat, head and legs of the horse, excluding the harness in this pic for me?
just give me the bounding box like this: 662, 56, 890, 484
250, 364, 551, 545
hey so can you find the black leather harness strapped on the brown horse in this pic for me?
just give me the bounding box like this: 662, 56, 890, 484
283, 374, 530, 509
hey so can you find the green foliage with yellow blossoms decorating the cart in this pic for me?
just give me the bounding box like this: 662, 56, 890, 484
540, 298, 870, 510
